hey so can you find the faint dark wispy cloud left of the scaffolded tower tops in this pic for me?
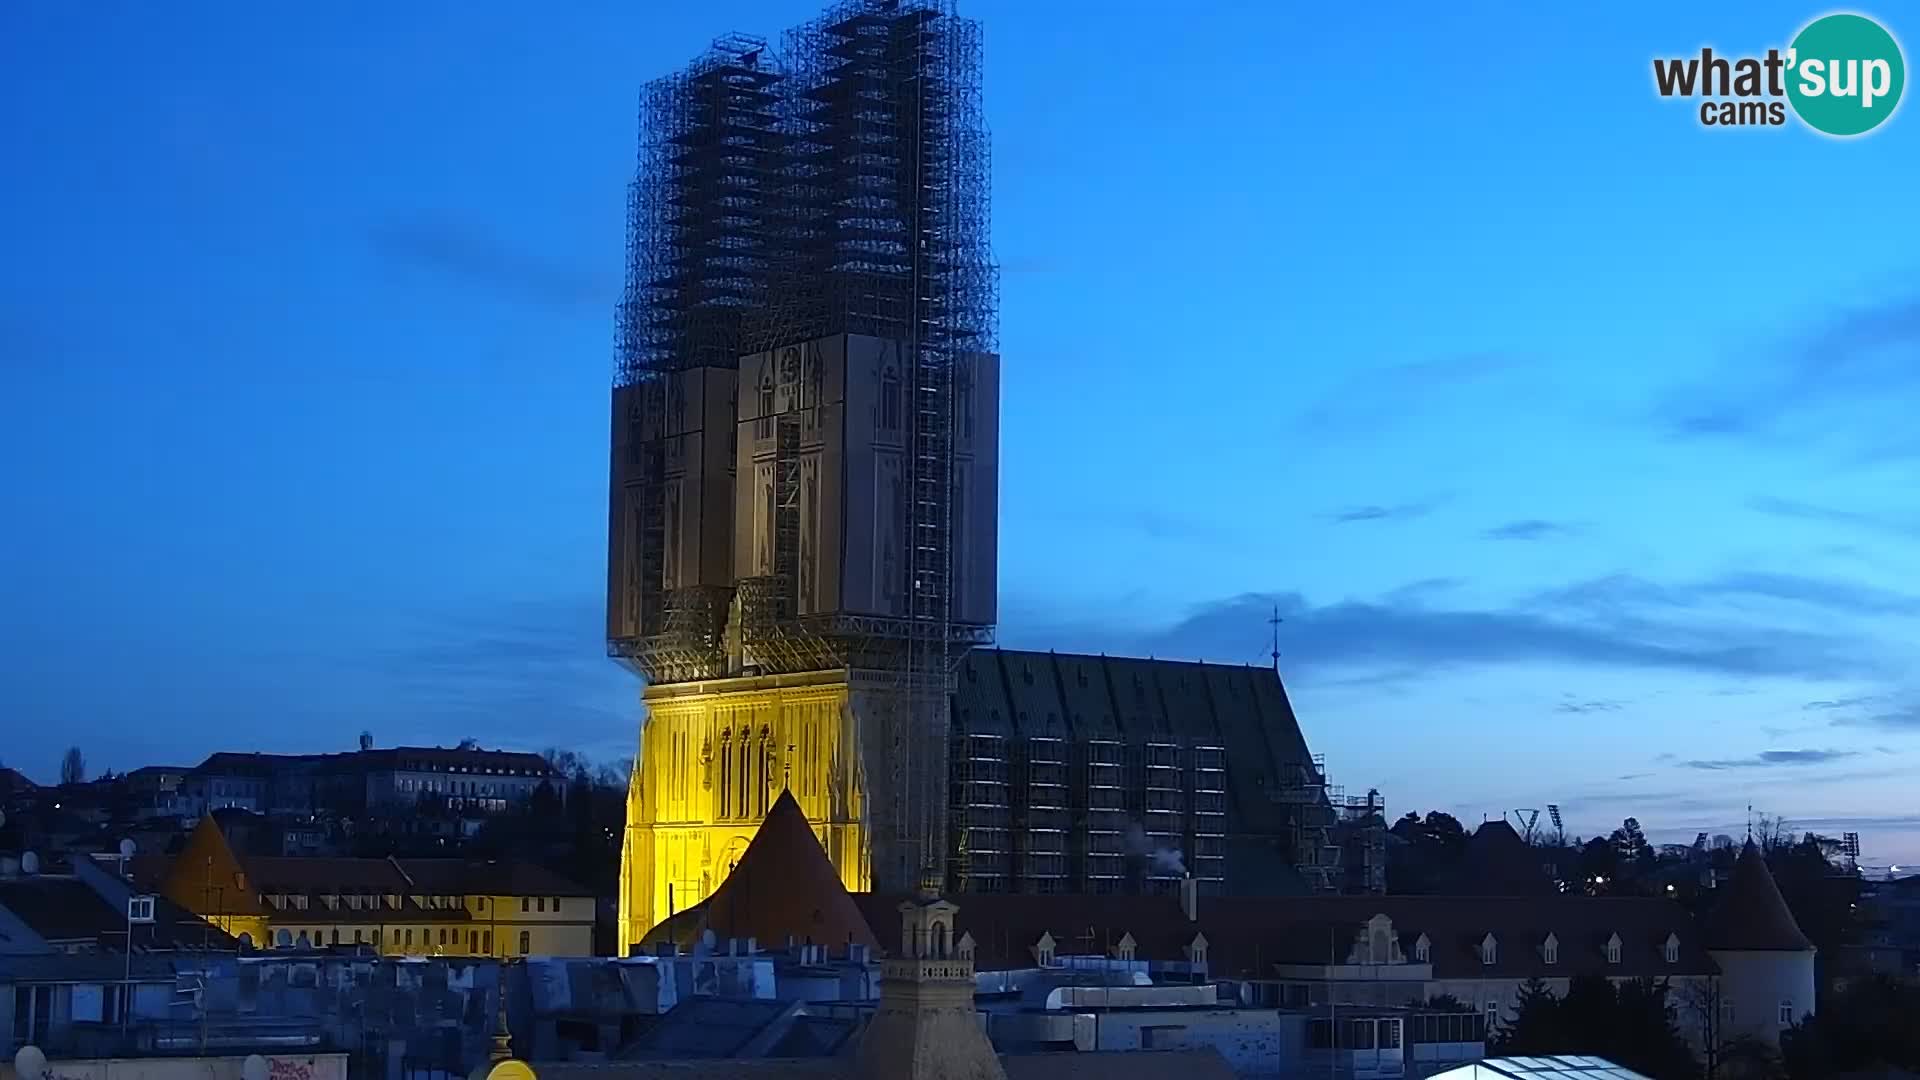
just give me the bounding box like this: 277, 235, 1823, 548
369, 213, 620, 313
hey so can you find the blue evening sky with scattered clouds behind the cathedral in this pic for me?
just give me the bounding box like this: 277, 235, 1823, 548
0, 0, 1920, 863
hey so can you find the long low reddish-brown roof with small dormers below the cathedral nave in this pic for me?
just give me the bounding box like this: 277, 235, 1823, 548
854, 894, 1716, 978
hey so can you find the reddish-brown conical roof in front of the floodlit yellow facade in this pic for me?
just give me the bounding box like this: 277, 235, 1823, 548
701, 792, 879, 947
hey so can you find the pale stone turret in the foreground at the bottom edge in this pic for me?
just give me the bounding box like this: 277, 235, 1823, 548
854, 871, 1006, 1080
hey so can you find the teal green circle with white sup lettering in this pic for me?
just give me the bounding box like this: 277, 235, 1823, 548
1788, 13, 1907, 136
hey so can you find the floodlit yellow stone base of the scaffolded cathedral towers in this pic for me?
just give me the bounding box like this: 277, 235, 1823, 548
620, 671, 872, 955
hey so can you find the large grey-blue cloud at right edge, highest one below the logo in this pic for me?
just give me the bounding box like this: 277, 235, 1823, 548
1655, 294, 1920, 461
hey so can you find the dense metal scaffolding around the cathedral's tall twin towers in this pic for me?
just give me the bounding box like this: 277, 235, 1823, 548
609, 0, 998, 888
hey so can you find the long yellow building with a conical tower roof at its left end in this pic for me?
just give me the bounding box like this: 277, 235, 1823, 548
148, 817, 597, 957
